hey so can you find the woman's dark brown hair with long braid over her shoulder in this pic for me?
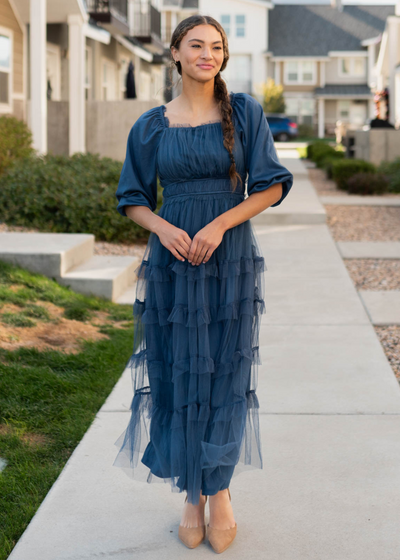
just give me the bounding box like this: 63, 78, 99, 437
169, 14, 242, 191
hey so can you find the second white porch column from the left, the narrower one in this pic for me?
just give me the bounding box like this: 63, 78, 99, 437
68, 14, 86, 156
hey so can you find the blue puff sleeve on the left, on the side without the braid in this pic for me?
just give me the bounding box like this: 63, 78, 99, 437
115, 107, 163, 216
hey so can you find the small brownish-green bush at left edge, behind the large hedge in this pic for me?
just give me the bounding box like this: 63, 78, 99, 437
0, 115, 35, 175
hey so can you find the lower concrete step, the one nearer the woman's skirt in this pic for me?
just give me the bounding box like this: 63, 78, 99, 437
58, 255, 139, 301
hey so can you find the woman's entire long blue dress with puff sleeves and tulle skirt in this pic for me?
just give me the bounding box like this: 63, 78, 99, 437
114, 93, 293, 504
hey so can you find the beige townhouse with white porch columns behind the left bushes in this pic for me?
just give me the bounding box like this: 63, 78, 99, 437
0, 0, 165, 159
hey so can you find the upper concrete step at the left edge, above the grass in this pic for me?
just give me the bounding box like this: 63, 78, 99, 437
0, 232, 95, 278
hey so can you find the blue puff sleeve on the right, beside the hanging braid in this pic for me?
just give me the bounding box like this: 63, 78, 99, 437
235, 93, 293, 206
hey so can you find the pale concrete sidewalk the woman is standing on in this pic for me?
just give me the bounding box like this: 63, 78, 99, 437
10, 154, 400, 560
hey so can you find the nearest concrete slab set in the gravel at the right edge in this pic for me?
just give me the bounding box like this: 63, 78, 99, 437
358, 290, 400, 326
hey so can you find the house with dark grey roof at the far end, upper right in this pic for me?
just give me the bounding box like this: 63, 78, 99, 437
268, 0, 394, 137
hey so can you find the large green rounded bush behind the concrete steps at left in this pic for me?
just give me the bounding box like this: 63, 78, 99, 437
0, 153, 161, 242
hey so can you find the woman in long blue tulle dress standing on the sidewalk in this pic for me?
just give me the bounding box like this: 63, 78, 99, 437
114, 15, 293, 552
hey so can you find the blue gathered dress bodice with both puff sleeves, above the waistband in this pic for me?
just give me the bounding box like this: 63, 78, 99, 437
116, 92, 293, 216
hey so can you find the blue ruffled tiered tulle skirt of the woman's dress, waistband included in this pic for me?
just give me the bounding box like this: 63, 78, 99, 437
114, 180, 266, 504
